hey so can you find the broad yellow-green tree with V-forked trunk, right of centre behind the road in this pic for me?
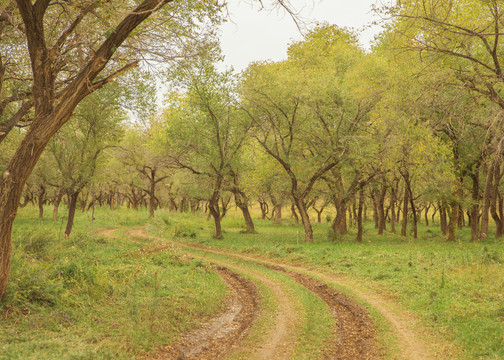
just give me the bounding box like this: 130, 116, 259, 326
241, 25, 367, 242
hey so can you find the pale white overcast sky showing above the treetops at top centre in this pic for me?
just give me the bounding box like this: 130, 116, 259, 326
221, 0, 378, 71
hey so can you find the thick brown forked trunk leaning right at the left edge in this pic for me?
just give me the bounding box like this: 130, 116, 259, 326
0, 0, 169, 299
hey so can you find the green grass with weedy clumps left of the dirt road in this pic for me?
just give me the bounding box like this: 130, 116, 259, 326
0, 208, 226, 359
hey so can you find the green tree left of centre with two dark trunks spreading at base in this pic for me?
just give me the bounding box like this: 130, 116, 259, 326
165, 59, 254, 239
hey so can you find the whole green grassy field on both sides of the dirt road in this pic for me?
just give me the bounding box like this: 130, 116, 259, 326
0, 204, 504, 359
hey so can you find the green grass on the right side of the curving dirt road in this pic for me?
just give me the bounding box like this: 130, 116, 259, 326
156, 213, 504, 359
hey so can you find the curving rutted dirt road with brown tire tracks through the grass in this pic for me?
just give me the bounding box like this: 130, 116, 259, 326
113, 229, 446, 360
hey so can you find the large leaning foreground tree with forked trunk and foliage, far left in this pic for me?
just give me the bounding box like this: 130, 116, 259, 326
0, 0, 224, 298
